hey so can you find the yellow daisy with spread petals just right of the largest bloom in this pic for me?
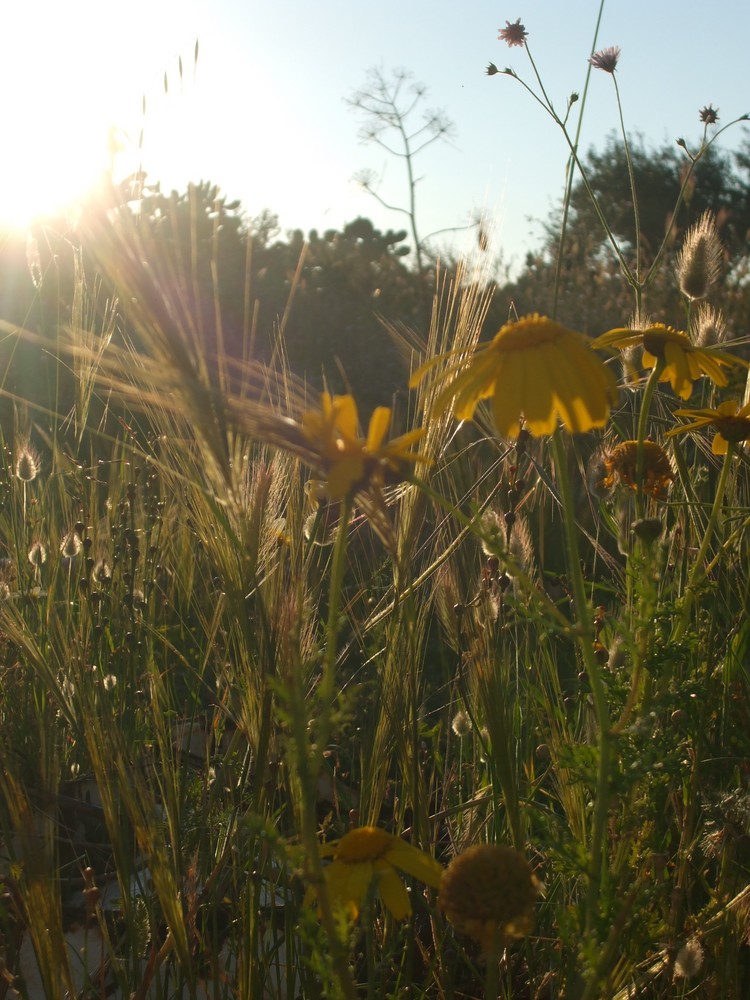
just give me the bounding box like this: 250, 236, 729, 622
591, 323, 744, 399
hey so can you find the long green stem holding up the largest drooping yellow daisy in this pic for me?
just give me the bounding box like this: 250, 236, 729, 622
552, 428, 613, 934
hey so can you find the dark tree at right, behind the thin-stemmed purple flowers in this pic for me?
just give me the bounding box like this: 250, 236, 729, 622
495, 136, 750, 334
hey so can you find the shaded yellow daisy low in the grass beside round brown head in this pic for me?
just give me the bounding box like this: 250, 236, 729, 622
305, 826, 443, 920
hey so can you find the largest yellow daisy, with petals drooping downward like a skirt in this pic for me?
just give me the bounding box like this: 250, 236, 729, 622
410, 314, 617, 437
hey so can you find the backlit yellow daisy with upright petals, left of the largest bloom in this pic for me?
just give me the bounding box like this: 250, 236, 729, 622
301, 392, 426, 500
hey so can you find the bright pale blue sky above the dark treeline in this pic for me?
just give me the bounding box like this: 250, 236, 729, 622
0, 0, 750, 274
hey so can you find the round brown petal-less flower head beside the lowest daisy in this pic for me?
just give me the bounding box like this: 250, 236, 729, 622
438, 844, 540, 953
